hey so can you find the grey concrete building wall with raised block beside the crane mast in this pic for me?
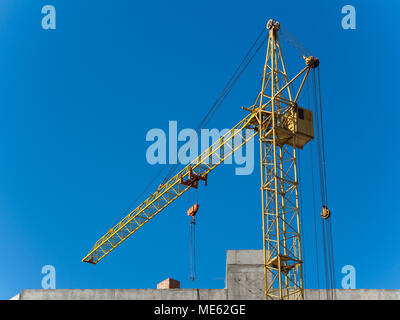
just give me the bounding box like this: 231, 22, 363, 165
12, 250, 400, 300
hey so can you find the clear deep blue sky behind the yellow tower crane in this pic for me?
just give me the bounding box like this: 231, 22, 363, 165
0, 0, 400, 299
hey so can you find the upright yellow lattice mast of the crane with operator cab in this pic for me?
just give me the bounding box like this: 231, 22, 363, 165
249, 20, 319, 300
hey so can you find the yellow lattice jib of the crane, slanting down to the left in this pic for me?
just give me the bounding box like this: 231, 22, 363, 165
82, 113, 258, 264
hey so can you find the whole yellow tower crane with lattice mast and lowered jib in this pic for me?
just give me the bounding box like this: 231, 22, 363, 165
82, 20, 319, 299
